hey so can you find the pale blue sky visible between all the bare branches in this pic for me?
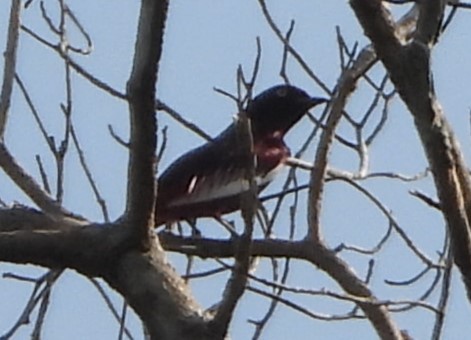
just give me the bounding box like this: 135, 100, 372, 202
0, 0, 471, 340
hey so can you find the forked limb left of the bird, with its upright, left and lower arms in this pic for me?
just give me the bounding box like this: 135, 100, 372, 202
0, 0, 225, 339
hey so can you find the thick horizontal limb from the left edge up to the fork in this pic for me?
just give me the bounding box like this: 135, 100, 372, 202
0, 207, 125, 276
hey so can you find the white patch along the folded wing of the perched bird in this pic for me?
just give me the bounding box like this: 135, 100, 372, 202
169, 163, 284, 207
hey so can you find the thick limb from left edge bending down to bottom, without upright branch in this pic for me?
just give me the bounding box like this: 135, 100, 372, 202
0, 207, 214, 339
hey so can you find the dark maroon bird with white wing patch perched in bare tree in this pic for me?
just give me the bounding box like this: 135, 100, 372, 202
154, 85, 327, 227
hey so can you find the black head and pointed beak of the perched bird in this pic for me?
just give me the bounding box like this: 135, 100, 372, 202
247, 85, 327, 136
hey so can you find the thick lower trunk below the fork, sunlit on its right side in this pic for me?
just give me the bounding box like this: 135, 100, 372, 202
105, 246, 214, 340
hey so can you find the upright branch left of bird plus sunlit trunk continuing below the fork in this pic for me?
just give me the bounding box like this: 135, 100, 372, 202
117, 0, 210, 339
